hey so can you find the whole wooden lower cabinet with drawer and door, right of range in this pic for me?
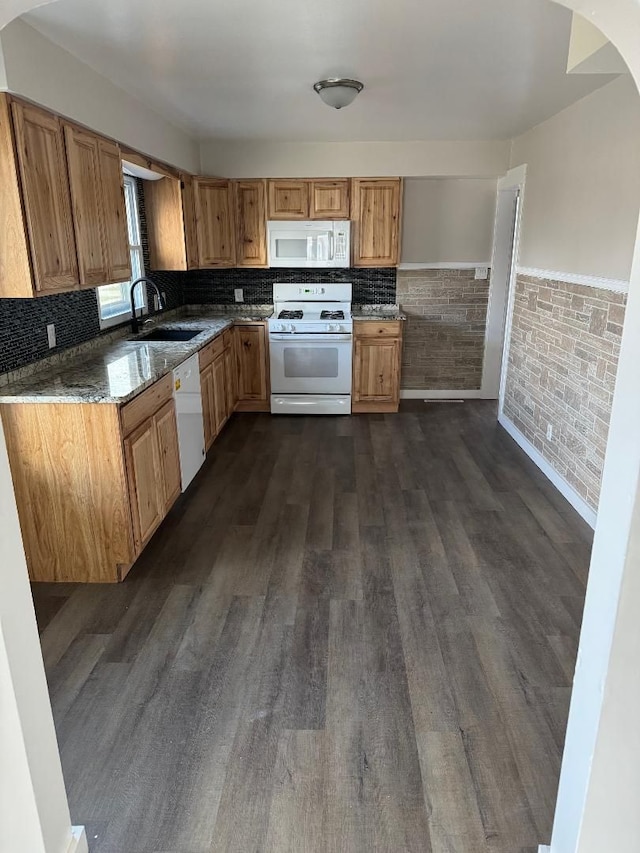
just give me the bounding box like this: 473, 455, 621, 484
352, 320, 402, 414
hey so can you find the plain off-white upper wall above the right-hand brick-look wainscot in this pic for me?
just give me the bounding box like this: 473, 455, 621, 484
511, 75, 640, 280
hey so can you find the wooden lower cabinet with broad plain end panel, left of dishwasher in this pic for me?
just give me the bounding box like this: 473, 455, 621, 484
0, 376, 181, 583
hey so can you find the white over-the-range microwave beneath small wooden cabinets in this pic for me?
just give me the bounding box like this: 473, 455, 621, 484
267, 220, 351, 268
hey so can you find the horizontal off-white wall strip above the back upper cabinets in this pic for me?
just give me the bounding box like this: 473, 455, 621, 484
200, 140, 509, 178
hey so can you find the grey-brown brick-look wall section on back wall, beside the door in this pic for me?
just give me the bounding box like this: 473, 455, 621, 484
396, 269, 489, 391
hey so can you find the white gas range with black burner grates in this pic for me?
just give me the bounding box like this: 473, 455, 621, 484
269, 283, 353, 415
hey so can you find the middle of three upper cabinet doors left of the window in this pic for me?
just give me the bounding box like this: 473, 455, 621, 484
64, 124, 110, 287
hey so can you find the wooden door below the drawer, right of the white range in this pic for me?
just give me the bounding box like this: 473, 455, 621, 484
353, 338, 400, 403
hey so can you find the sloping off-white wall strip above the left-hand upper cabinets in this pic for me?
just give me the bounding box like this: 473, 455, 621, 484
0, 20, 200, 172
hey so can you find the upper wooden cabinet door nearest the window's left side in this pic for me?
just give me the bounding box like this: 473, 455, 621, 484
98, 139, 131, 282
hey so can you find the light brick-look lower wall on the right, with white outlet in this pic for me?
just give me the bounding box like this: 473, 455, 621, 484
504, 276, 627, 510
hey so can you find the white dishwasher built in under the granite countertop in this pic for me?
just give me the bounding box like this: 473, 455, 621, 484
173, 353, 205, 492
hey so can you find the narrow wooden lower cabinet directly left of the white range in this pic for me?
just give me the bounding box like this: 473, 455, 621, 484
235, 322, 270, 412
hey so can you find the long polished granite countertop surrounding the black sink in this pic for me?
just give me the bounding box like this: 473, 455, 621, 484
0, 315, 234, 404
